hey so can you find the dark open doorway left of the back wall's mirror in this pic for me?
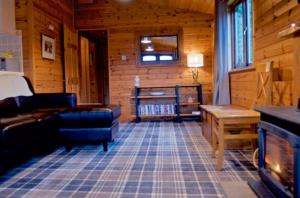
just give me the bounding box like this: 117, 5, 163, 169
79, 30, 109, 104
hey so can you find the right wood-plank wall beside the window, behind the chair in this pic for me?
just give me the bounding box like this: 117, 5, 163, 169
230, 0, 300, 108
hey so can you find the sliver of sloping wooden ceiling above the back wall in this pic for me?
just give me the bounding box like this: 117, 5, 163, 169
140, 0, 215, 14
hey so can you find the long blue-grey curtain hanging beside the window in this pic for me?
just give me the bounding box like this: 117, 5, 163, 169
213, 0, 230, 105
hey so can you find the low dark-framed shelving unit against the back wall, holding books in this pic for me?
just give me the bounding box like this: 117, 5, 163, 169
131, 84, 203, 122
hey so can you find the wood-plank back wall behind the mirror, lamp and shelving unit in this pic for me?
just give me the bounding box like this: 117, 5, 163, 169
75, 0, 213, 120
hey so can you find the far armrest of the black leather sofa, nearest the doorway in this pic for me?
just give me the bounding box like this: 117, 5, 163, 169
34, 93, 77, 108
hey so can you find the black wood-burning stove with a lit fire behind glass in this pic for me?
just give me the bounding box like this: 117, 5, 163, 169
249, 107, 300, 197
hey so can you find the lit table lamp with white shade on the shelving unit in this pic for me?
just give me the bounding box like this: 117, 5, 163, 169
187, 53, 204, 83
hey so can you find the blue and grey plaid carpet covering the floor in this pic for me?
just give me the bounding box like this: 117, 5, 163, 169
0, 122, 257, 198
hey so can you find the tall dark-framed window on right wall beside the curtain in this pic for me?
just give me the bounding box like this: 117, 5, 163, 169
232, 0, 253, 68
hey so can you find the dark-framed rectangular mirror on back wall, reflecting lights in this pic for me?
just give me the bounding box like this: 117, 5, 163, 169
140, 35, 179, 63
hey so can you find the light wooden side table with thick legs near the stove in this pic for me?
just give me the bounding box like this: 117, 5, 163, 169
200, 105, 260, 170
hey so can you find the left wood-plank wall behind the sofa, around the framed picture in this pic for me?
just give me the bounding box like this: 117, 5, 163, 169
15, 0, 74, 93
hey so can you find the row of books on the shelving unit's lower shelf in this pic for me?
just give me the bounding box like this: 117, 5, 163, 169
139, 104, 175, 116
